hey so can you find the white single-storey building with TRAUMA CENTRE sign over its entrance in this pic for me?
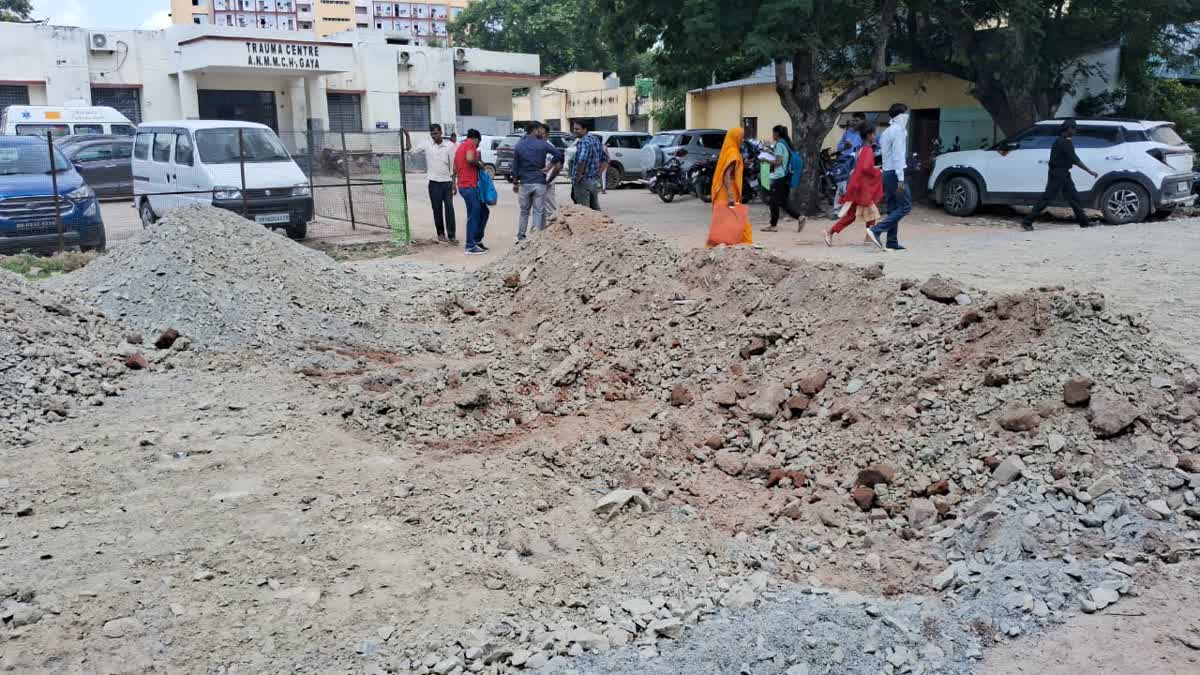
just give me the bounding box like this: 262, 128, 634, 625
0, 23, 542, 135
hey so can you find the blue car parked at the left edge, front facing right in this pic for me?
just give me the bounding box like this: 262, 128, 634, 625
0, 136, 104, 253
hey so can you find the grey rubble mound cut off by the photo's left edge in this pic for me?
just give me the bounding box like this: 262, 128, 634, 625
0, 270, 125, 444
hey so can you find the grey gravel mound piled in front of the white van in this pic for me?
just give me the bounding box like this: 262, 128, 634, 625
52, 207, 377, 350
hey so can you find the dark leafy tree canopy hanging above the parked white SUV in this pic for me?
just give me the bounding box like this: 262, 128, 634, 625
896, 0, 1200, 133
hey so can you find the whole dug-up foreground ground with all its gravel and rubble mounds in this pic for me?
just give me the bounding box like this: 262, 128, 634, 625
0, 201, 1200, 675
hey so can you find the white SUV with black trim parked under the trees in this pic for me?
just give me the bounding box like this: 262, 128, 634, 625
929, 119, 1195, 225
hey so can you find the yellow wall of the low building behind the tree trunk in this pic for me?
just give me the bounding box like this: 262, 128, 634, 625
686, 73, 982, 145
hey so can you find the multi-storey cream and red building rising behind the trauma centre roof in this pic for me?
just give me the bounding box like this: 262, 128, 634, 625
170, 0, 472, 38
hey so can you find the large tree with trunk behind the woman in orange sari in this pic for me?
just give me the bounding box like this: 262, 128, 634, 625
600, 0, 898, 211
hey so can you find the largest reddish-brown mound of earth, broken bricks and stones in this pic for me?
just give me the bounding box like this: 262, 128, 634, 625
342, 209, 1200, 538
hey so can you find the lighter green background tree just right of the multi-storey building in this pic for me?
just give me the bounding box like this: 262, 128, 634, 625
450, 0, 641, 82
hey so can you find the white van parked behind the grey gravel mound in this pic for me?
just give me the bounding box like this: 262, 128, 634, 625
133, 120, 312, 239
